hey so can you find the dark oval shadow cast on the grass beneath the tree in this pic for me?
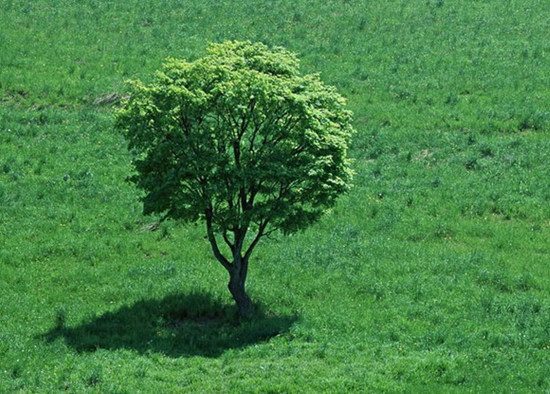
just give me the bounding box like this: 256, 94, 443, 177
42, 294, 297, 357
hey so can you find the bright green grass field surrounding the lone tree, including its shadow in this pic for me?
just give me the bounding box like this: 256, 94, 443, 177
0, 0, 550, 393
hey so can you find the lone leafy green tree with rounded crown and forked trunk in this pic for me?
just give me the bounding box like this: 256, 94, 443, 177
116, 41, 353, 316
